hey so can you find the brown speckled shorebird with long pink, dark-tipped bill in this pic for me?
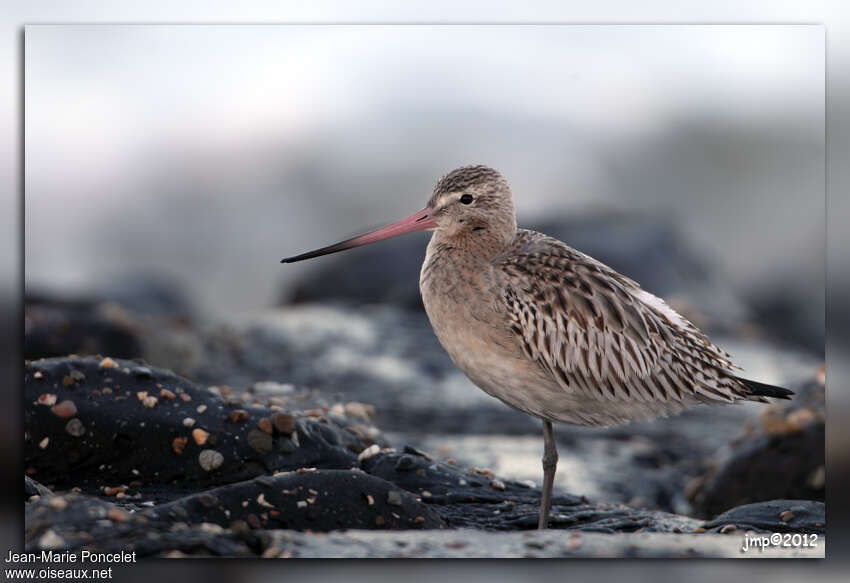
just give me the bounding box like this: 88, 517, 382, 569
281, 166, 793, 529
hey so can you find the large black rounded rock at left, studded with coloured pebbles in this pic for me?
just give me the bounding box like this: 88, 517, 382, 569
24, 358, 377, 495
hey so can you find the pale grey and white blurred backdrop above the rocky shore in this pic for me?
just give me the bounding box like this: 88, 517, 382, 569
4, 1, 846, 579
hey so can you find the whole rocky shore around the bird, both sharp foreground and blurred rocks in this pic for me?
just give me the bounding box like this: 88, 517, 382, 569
24, 224, 826, 558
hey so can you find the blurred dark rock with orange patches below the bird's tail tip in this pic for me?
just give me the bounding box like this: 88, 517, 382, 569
690, 381, 825, 518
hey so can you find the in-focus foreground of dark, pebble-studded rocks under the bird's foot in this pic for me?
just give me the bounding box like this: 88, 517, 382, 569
25, 344, 825, 557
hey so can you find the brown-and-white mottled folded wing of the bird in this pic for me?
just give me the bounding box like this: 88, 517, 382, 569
494, 231, 740, 402
